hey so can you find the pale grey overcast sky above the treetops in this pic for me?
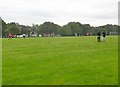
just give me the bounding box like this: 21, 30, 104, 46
0, 0, 119, 26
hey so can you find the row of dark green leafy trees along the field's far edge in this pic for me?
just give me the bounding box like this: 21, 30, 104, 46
2, 20, 118, 37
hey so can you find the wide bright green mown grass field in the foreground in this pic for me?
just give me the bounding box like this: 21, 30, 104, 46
2, 36, 118, 85
